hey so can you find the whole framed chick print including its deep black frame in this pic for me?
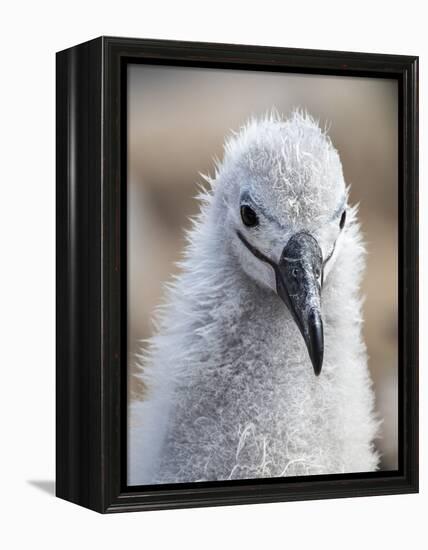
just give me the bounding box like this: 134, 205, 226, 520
57, 37, 418, 512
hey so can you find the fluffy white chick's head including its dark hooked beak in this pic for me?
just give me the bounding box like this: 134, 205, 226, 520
216, 111, 347, 375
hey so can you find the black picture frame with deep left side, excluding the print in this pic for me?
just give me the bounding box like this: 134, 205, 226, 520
56, 37, 418, 512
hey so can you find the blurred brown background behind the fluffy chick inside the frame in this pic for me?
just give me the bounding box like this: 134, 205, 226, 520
128, 65, 398, 469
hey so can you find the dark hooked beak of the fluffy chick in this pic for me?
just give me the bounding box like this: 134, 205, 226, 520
275, 232, 324, 376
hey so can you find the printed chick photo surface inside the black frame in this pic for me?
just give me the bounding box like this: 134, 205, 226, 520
127, 64, 398, 486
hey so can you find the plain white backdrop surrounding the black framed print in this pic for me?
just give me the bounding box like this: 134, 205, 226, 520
0, 0, 428, 549
